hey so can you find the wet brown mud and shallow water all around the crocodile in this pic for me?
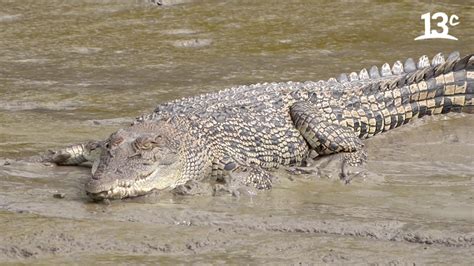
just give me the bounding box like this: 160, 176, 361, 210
0, 0, 474, 264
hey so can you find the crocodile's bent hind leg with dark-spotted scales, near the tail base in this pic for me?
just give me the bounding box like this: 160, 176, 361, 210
290, 102, 367, 183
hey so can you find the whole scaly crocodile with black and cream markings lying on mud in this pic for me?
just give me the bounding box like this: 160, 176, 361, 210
39, 52, 474, 200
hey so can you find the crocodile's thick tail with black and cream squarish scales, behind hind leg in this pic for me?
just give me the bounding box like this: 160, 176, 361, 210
343, 53, 474, 138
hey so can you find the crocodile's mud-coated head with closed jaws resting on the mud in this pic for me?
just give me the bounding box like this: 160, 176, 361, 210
86, 122, 181, 200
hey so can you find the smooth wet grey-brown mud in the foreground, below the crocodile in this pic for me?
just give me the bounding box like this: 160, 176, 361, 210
0, 115, 474, 264
